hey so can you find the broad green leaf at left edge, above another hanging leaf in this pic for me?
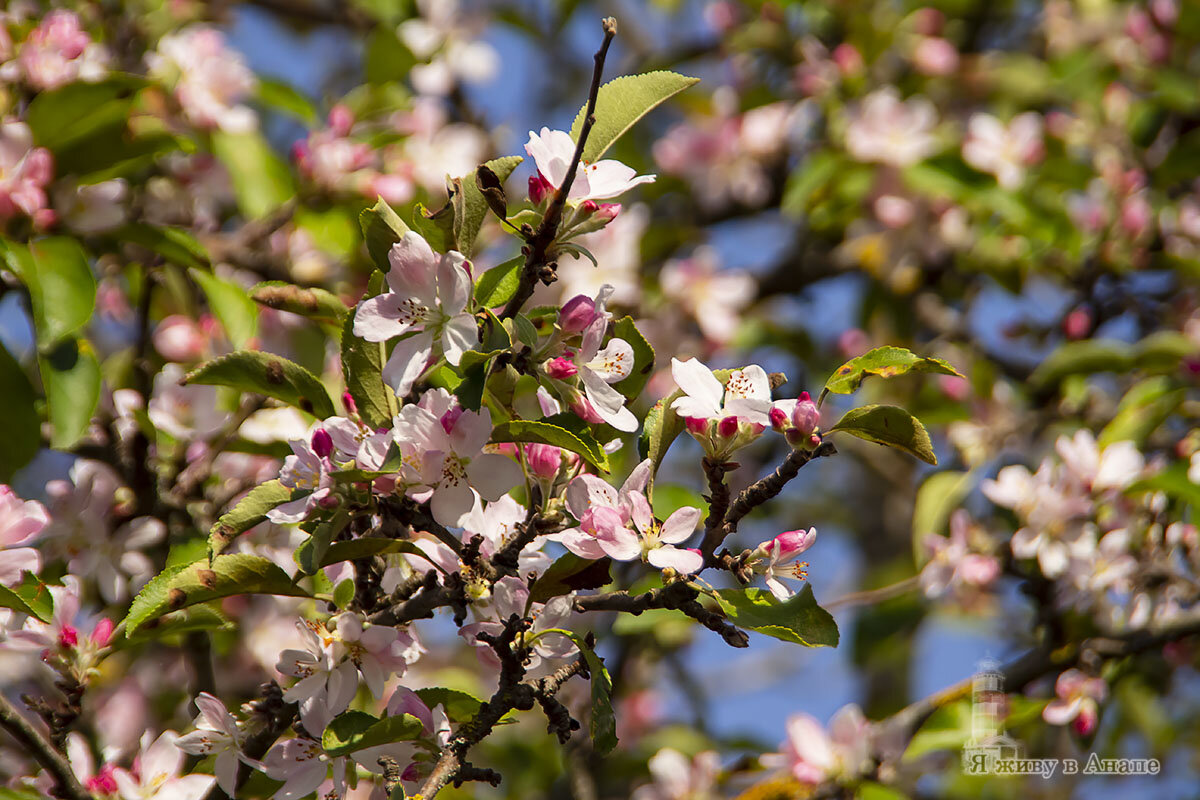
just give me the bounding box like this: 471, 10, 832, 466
5, 236, 96, 347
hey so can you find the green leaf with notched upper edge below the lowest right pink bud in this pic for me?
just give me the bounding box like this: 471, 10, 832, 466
714, 583, 838, 648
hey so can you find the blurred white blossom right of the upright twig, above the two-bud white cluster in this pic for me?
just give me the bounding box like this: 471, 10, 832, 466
659, 246, 758, 344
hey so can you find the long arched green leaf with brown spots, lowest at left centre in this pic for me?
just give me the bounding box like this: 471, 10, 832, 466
124, 553, 308, 636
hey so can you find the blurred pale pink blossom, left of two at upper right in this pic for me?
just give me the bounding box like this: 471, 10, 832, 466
846, 86, 937, 167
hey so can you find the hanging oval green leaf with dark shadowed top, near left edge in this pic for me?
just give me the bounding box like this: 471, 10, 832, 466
38, 339, 101, 450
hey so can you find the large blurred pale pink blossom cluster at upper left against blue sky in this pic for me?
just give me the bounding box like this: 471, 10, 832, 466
146, 25, 258, 133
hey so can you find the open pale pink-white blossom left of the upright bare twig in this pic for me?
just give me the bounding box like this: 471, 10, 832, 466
354, 231, 479, 396
